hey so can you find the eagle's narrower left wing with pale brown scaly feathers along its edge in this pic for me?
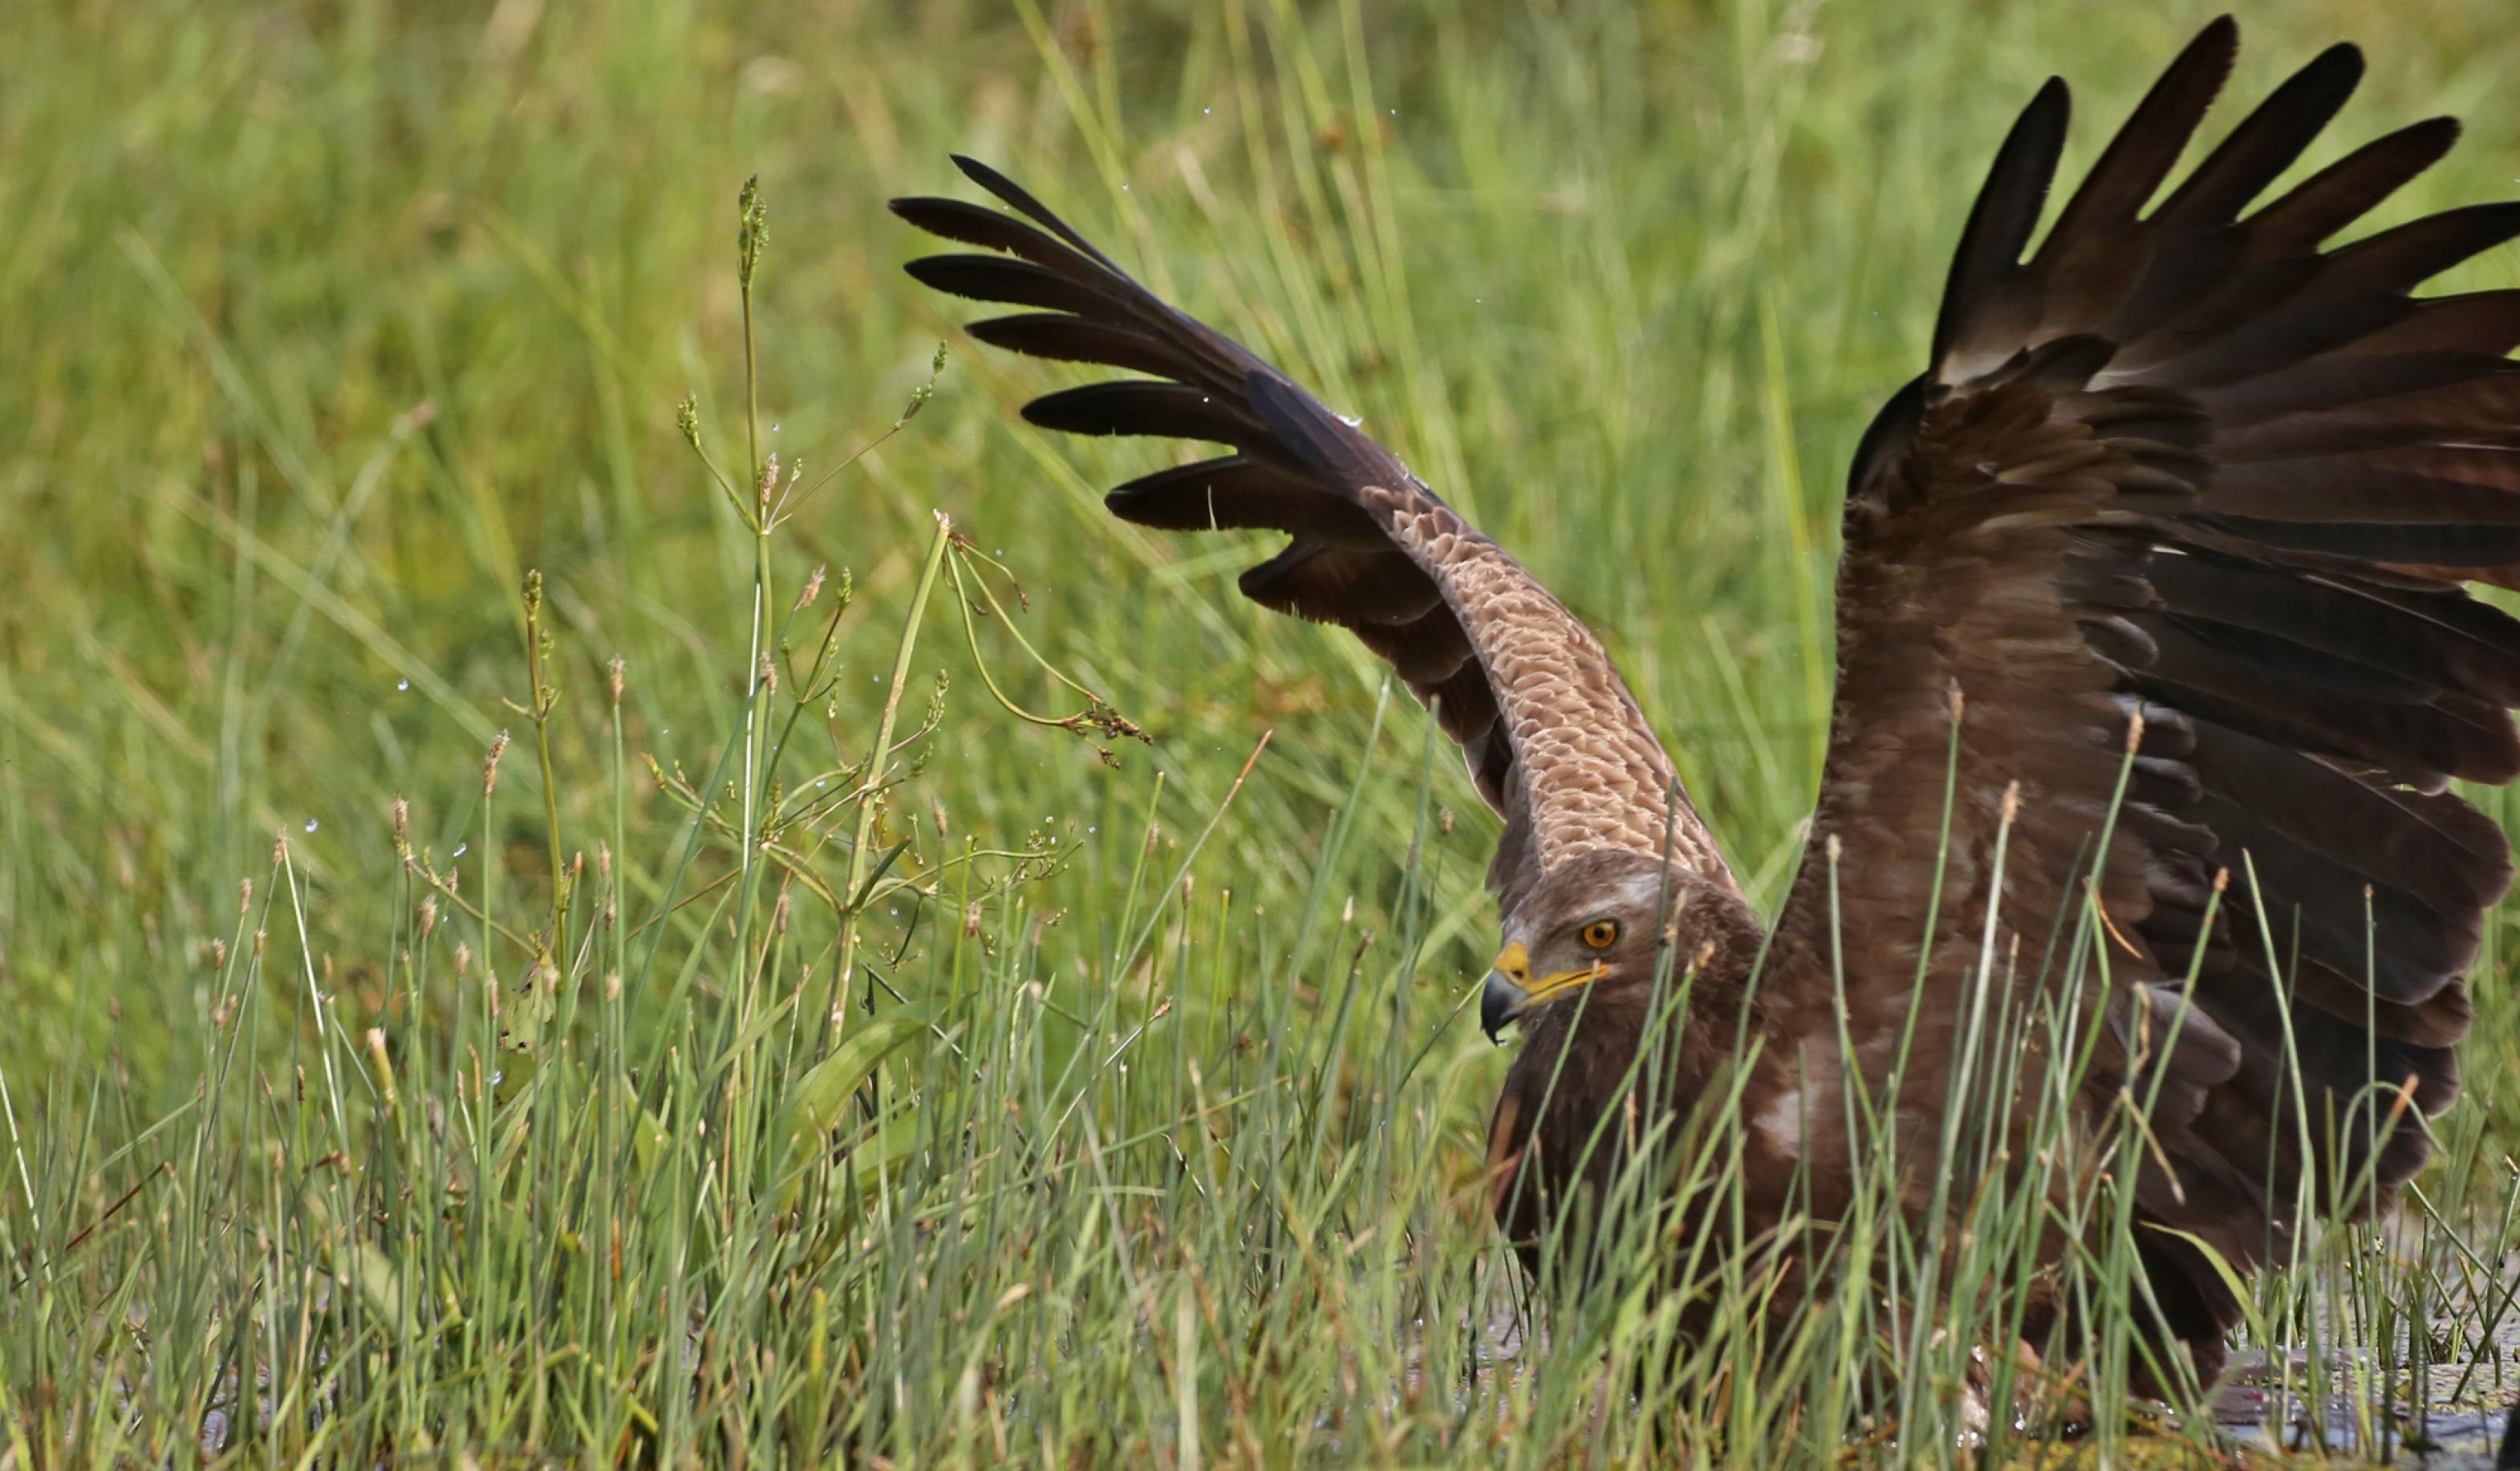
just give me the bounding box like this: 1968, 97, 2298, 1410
892, 159, 1729, 912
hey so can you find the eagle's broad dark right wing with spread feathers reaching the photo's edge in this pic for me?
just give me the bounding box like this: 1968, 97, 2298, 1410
1774, 18, 2520, 1370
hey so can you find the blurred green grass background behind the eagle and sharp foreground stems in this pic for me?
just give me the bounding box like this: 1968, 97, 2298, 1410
0, 0, 2520, 1103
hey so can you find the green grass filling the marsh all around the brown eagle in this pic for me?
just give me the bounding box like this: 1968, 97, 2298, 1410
14, 0, 2520, 1471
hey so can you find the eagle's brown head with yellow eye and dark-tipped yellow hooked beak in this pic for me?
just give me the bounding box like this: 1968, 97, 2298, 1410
1479, 849, 1747, 1040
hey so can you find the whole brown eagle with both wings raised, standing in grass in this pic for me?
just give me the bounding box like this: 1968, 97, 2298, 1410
892, 18, 2520, 1383
